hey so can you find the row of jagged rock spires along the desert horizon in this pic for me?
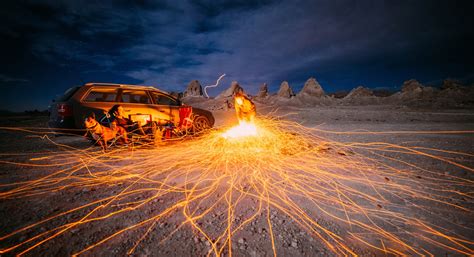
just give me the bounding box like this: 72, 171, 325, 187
205, 75, 474, 110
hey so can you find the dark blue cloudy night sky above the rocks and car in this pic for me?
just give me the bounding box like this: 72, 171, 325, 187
0, 0, 474, 111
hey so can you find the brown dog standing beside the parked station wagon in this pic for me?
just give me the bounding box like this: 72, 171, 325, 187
84, 113, 128, 151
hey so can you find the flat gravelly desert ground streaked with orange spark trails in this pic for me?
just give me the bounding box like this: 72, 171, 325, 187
0, 103, 474, 256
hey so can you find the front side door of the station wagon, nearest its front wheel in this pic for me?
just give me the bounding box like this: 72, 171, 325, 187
120, 88, 170, 125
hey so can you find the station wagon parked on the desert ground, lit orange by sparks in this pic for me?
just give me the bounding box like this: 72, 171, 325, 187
48, 83, 214, 132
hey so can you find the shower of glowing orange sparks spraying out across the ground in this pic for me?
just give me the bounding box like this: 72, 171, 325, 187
0, 118, 474, 256
